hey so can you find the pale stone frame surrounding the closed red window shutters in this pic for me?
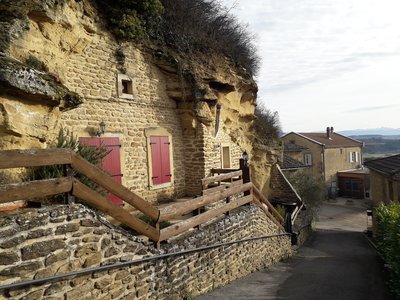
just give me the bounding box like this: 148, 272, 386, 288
144, 127, 175, 190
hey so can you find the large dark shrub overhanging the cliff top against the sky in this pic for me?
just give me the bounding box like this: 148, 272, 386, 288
161, 0, 260, 75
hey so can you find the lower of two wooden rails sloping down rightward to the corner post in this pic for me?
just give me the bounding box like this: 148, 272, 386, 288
72, 179, 160, 242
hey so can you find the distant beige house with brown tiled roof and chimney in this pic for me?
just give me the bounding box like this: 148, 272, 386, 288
282, 127, 363, 194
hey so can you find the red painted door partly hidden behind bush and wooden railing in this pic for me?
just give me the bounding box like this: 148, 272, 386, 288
79, 137, 122, 205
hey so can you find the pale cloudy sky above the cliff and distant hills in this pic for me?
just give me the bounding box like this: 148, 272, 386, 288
222, 0, 400, 132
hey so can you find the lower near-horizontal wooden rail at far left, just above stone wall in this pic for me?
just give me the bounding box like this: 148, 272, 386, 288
0, 177, 72, 203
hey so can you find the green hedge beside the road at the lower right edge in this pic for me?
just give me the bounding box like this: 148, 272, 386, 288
375, 203, 400, 298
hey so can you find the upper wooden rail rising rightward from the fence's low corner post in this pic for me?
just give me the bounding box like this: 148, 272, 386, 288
160, 182, 252, 222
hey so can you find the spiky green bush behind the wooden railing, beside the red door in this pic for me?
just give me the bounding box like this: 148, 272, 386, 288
25, 128, 110, 202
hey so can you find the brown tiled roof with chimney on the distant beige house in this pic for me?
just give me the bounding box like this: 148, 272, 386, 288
297, 132, 363, 148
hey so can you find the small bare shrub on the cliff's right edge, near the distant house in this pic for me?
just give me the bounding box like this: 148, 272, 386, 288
253, 104, 282, 145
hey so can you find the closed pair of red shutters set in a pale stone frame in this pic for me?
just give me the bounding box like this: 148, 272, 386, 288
150, 136, 172, 185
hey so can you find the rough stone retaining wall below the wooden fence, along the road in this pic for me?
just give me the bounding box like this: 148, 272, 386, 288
0, 204, 291, 299
